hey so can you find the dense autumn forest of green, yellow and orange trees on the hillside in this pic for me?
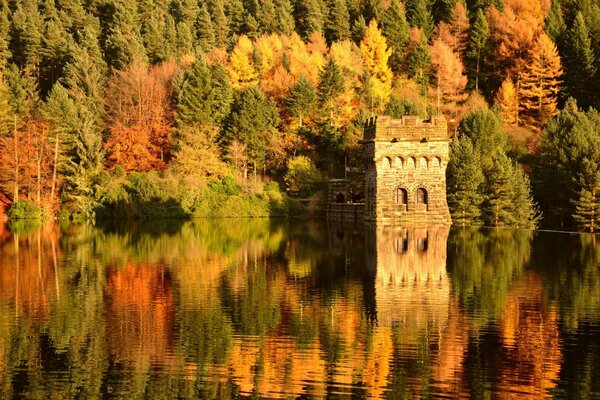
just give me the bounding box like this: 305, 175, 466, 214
0, 0, 600, 231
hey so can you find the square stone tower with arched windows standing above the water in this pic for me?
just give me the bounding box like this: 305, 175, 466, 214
363, 116, 452, 224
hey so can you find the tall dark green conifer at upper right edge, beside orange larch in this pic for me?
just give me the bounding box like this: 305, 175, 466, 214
564, 13, 598, 108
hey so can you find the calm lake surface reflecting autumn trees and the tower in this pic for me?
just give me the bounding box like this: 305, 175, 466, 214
0, 220, 600, 399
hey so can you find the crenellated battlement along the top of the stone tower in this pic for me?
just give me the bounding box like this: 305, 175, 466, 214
364, 115, 448, 142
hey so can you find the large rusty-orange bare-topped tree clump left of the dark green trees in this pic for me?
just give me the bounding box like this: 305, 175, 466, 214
106, 63, 177, 171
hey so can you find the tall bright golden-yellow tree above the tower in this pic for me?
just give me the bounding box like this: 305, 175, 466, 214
360, 20, 393, 109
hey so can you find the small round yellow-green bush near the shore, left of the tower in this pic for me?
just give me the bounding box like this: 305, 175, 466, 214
283, 156, 323, 198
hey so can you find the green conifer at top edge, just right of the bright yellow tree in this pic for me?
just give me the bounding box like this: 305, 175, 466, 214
381, 0, 410, 72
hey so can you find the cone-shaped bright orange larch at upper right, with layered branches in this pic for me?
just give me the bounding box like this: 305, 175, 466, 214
519, 33, 562, 128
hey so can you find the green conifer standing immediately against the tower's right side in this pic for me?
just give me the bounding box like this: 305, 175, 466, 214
446, 137, 484, 226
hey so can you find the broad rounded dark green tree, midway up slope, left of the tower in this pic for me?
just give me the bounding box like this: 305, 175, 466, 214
221, 88, 280, 176
